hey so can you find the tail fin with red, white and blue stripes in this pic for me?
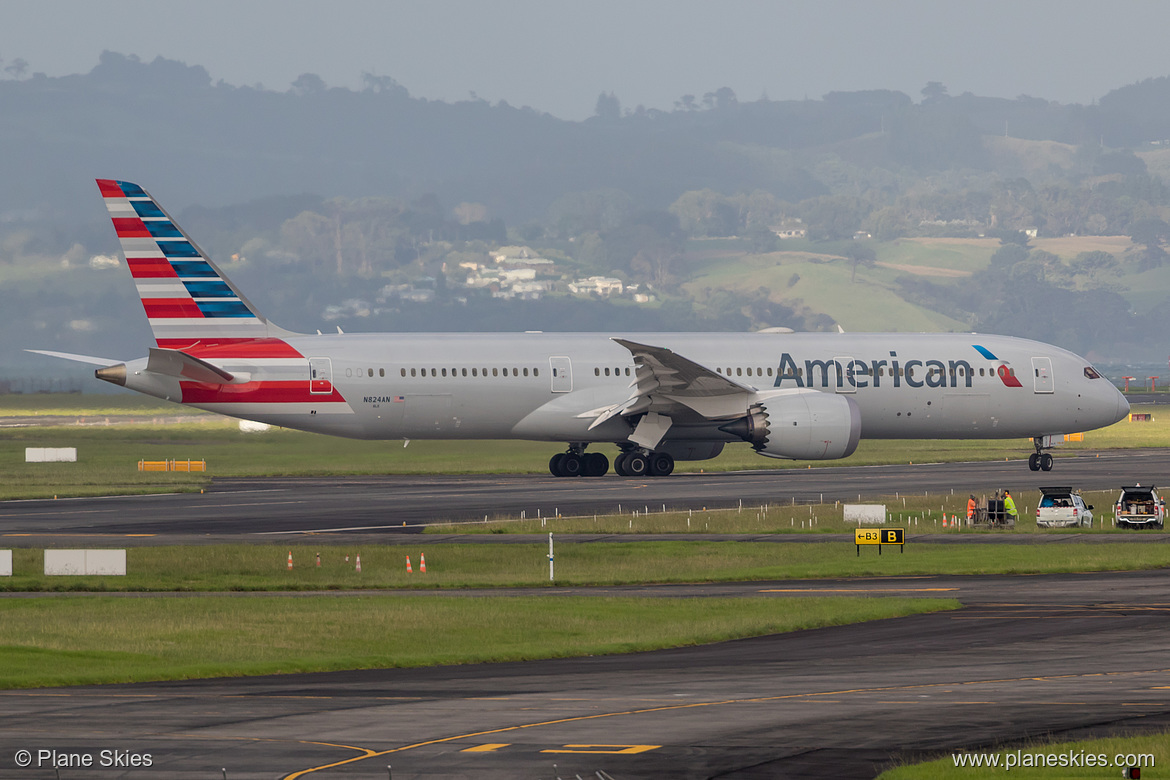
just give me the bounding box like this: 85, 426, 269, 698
97, 179, 291, 350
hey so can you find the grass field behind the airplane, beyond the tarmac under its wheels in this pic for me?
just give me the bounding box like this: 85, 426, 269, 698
0, 395, 1170, 499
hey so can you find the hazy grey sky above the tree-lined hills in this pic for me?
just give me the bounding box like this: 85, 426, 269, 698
0, 0, 1170, 119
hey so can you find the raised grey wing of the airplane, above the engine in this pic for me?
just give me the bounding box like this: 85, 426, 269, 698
581, 338, 755, 449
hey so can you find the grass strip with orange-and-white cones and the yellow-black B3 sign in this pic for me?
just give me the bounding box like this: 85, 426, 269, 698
0, 536, 1170, 592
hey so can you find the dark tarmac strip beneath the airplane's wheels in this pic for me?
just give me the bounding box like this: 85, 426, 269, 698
0, 449, 1170, 546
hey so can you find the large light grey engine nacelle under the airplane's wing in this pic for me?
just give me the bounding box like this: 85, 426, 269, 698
720, 388, 861, 461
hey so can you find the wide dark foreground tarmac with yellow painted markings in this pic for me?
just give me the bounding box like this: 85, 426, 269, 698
0, 572, 1170, 780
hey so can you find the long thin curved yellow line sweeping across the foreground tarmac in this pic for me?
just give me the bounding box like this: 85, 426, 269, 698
281, 669, 1170, 780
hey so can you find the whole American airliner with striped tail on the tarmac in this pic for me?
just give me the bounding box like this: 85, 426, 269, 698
33, 179, 1129, 477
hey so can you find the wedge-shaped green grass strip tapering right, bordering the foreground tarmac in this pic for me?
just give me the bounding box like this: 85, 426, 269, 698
0, 595, 958, 689
